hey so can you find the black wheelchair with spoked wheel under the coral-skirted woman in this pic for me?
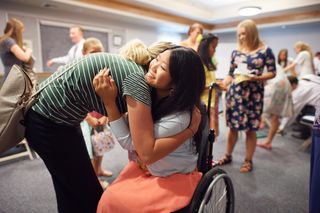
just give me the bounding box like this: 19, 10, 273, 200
175, 83, 235, 213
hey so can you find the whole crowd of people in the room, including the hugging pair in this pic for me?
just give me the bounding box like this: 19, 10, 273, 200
0, 18, 320, 213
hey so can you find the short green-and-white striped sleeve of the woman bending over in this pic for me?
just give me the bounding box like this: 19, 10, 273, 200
122, 73, 151, 107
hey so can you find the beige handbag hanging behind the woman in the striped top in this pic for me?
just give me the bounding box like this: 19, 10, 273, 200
0, 65, 67, 153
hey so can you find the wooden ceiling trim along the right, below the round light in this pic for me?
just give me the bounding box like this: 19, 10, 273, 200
212, 11, 320, 30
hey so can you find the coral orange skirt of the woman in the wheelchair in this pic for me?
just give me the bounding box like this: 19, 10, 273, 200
97, 161, 202, 213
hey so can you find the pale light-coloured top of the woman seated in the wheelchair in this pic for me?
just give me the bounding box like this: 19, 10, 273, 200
110, 112, 198, 177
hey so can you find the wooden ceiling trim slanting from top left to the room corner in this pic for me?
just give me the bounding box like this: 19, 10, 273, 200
79, 0, 214, 30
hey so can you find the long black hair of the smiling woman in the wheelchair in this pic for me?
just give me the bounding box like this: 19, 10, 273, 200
152, 46, 205, 151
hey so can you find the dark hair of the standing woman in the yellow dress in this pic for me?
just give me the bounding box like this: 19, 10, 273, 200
198, 33, 219, 71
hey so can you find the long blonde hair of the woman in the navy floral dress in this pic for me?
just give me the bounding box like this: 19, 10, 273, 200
237, 19, 263, 50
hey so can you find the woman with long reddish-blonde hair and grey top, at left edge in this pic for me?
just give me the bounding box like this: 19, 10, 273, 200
0, 18, 32, 82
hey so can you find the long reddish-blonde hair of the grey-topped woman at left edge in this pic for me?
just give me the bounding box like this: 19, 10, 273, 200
0, 18, 24, 49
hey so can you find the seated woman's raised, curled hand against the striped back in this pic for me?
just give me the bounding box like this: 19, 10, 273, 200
93, 68, 118, 105
